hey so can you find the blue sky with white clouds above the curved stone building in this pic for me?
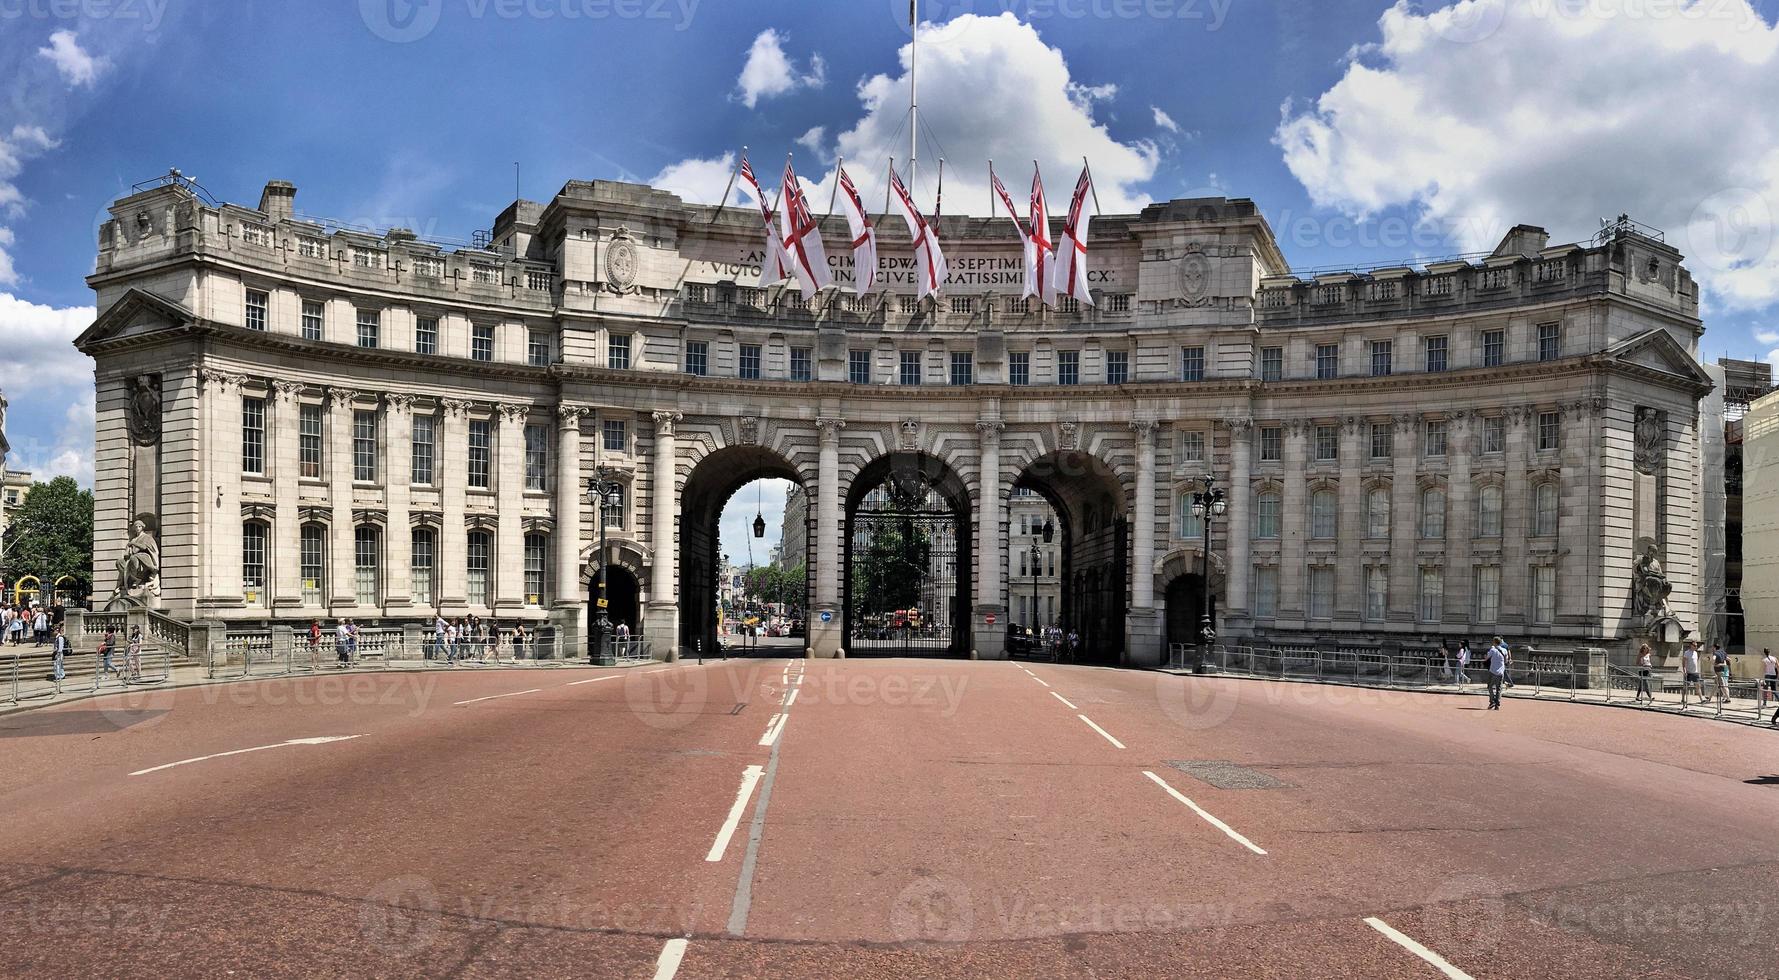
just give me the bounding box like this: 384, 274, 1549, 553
0, 0, 1779, 534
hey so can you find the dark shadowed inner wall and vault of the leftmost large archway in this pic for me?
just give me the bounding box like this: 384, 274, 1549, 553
676, 446, 815, 656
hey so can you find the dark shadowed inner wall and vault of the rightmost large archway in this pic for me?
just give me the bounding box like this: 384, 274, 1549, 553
1012, 450, 1130, 663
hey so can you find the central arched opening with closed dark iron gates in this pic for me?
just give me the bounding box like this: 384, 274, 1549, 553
845, 452, 973, 656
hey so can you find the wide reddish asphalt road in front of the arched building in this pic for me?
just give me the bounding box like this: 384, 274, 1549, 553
0, 660, 1779, 978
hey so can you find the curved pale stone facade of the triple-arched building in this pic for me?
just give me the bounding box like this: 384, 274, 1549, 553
76, 181, 1710, 665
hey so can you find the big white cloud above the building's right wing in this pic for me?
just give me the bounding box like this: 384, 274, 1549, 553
1274, 0, 1779, 309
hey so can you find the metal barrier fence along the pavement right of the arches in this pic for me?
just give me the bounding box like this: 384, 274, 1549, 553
1167, 644, 1779, 724
